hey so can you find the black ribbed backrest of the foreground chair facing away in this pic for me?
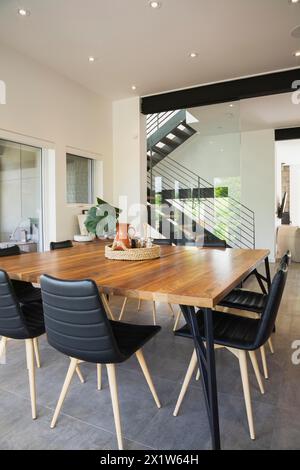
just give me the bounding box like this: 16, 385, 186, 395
40, 275, 122, 364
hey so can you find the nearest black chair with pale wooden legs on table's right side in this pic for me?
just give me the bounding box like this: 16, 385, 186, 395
174, 262, 288, 439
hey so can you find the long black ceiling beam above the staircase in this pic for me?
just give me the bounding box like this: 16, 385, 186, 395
141, 68, 300, 114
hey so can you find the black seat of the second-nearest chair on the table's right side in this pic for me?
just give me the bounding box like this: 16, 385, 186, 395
219, 289, 268, 313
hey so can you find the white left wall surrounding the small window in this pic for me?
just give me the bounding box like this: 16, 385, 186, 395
0, 45, 113, 246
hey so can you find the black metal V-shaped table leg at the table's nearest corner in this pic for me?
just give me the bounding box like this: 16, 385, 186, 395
181, 305, 221, 450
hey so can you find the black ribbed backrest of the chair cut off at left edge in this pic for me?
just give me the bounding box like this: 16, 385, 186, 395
0, 270, 29, 339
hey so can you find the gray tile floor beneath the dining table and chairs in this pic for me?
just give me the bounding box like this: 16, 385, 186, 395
0, 264, 300, 450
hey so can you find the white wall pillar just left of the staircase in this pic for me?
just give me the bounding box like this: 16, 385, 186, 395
113, 97, 147, 229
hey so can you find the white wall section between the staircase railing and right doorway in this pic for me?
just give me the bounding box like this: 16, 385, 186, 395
241, 129, 276, 260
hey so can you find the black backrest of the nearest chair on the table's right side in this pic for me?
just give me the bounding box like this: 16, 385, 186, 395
254, 262, 288, 349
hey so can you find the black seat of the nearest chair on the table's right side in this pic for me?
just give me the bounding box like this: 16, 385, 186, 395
175, 310, 260, 350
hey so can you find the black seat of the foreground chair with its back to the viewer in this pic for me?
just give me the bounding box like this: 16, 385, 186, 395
110, 320, 161, 360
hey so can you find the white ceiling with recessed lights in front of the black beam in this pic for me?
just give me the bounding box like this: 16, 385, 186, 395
0, 0, 300, 99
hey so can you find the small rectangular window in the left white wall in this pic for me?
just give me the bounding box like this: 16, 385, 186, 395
67, 153, 94, 204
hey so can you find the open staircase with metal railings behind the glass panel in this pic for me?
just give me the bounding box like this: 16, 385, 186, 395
147, 111, 255, 249
